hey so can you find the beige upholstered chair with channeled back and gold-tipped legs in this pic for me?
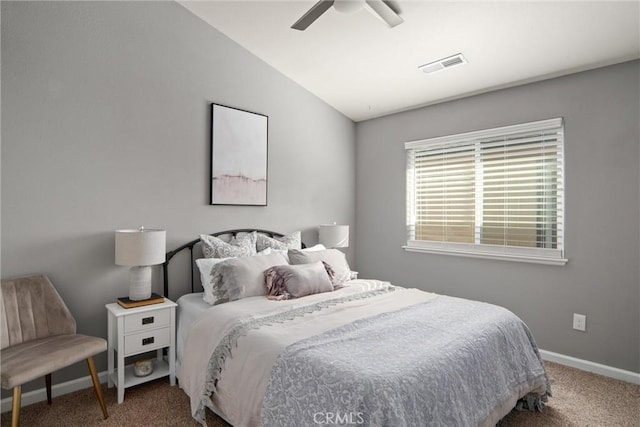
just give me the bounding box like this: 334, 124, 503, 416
0, 275, 109, 426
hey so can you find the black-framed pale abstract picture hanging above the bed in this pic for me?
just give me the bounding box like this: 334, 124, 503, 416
210, 103, 269, 206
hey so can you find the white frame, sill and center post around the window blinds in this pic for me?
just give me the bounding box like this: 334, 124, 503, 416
403, 118, 568, 265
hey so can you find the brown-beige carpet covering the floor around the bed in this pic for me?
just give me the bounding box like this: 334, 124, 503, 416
2, 362, 640, 427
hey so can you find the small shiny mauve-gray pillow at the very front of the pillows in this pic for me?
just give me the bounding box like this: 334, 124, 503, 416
264, 261, 333, 300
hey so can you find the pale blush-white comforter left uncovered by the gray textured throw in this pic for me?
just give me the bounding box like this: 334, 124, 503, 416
179, 280, 437, 426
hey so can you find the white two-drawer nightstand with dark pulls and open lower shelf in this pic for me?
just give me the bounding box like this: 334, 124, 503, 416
106, 298, 177, 403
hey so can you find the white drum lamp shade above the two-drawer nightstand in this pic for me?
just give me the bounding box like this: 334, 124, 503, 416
116, 228, 167, 267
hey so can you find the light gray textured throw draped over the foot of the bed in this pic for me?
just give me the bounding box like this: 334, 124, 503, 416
262, 296, 551, 427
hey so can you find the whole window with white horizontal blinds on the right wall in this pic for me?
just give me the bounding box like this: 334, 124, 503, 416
404, 119, 567, 265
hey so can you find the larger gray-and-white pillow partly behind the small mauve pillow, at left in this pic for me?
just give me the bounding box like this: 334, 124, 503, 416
207, 253, 286, 305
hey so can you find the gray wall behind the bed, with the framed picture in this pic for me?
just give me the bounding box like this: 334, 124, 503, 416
1, 1, 355, 389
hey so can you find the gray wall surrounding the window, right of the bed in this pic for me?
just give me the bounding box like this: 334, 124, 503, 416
356, 61, 640, 372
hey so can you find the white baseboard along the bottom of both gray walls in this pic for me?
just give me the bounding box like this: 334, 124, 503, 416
1, 350, 640, 412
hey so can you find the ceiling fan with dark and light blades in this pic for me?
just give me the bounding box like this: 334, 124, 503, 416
291, 0, 404, 31
